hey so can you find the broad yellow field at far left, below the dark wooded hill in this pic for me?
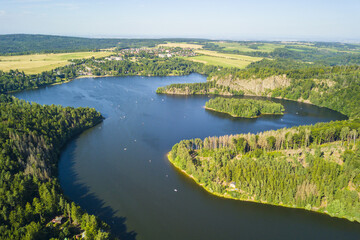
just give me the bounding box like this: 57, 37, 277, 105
0, 52, 112, 74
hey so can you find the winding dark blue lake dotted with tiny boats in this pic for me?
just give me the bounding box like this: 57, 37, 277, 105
14, 74, 360, 240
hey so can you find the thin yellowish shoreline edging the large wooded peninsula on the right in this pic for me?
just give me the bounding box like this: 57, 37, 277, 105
166, 151, 360, 224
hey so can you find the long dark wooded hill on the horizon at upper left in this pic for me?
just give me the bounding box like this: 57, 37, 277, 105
0, 34, 205, 55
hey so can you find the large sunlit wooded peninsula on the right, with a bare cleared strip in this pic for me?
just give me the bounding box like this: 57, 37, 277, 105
168, 120, 360, 222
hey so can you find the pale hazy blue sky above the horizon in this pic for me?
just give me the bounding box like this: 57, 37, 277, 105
0, 0, 360, 42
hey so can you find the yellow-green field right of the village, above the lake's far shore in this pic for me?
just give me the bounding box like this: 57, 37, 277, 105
186, 50, 263, 68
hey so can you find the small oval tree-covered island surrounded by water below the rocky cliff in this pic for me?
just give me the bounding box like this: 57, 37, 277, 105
205, 97, 285, 118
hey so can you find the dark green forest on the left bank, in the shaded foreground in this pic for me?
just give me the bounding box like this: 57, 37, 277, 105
0, 95, 110, 240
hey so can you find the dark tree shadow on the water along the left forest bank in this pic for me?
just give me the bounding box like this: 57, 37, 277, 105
59, 139, 137, 240
